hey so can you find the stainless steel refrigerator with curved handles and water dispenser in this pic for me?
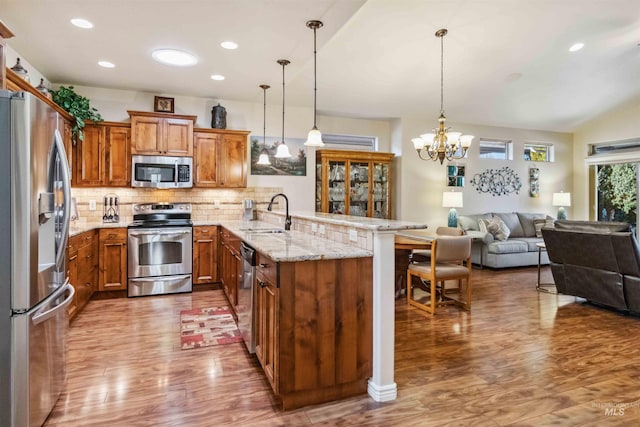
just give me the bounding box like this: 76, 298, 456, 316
0, 91, 74, 427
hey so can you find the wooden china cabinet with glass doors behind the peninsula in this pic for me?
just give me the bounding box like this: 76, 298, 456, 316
316, 150, 395, 219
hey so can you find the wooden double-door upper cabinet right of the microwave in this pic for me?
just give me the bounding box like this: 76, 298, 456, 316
193, 129, 249, 188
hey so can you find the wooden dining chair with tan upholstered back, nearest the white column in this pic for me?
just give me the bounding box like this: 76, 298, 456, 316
407, 236, 471, 314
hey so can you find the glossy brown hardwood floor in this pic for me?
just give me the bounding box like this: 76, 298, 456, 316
45, 267, 640, 427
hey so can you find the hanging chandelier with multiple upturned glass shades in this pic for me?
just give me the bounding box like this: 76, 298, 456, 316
411, 28, 473, 164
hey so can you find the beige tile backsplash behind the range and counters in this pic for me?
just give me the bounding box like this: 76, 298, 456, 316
71, 187, 282, 227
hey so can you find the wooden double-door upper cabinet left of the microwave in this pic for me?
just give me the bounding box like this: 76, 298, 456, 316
73, 122, 131, 187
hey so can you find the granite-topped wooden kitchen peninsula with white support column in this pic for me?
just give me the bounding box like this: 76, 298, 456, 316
73, 210, 426, 409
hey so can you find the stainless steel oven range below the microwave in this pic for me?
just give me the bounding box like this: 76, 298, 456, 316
127, 203, 193, 297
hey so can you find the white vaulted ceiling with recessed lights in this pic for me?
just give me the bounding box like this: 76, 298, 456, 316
0, 0, 640, 132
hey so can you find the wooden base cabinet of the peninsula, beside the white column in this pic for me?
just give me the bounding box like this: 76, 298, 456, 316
256, 254, 373, 410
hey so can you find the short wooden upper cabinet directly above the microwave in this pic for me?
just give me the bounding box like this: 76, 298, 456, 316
129, 111, 197, 157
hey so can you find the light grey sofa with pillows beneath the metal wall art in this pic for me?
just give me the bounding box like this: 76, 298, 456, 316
458, 212, 553, 268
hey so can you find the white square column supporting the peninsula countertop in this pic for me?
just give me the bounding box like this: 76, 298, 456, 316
367, 230, 398, 402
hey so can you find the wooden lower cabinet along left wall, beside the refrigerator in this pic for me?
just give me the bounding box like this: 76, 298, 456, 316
67, 230, 98, 318
